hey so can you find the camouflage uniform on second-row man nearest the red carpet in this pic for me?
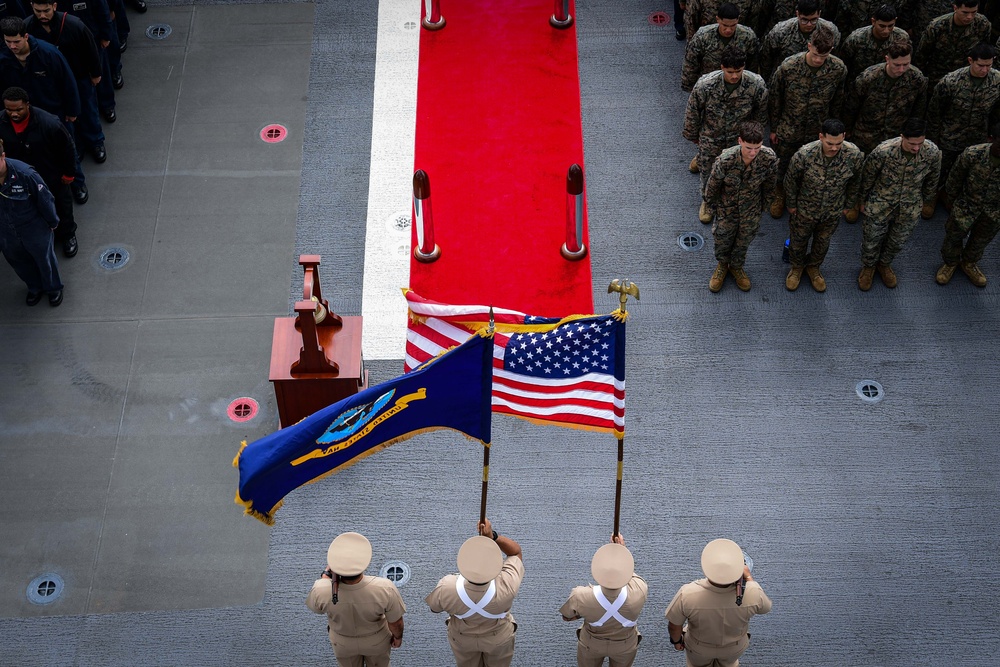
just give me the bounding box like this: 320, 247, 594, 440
683, 70, 767, 192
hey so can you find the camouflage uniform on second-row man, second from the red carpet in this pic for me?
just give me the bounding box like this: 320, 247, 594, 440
767, 53, 847, 178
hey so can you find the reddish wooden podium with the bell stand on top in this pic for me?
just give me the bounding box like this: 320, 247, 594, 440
269, 255, 368, 428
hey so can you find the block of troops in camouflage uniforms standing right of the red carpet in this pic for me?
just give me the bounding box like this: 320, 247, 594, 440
677, 0, 1000, 292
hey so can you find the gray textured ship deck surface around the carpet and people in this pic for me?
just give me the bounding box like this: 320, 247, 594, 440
0, 0, 1000, 667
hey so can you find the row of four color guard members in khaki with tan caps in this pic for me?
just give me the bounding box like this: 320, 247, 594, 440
306, 519, 771, 667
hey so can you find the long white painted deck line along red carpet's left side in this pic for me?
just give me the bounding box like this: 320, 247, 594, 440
361, 0, 421, 359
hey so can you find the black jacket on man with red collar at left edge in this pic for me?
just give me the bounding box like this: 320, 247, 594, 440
0, 107, 76, 190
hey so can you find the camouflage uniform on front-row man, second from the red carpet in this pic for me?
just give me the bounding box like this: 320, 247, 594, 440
785, 141, 865, 267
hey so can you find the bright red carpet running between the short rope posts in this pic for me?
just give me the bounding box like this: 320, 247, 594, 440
410, 0, 593, 317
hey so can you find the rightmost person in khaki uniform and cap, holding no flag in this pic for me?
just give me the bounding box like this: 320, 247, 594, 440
666, 539, 771, 667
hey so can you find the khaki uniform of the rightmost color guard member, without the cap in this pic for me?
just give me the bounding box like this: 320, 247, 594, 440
665, 579, 771, 667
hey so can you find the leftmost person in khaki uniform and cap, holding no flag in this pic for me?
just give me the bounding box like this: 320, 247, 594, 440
306, 533, 406, 667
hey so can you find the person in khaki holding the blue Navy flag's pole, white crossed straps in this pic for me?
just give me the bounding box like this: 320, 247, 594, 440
424, 519, 524, 667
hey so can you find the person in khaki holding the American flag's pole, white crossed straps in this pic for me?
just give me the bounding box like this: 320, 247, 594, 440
559, 534, 649, 667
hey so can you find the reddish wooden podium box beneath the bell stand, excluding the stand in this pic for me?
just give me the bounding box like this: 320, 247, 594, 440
269, 316, 368, 428
